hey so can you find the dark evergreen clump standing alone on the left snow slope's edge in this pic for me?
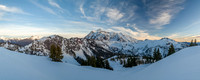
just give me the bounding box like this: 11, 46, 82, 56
49, 44, 63, 62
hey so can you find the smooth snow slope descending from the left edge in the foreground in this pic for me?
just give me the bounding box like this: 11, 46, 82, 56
0, 47, 112, 80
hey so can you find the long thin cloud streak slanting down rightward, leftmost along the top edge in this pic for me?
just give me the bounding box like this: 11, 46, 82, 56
31, 0, 57, 15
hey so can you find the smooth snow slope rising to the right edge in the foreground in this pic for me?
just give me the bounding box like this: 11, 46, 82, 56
122, 46, 200, 80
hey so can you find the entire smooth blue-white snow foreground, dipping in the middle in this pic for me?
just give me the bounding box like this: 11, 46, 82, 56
0, 47, 200, 80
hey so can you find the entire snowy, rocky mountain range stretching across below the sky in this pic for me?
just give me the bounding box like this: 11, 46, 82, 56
0, 29, 188, 63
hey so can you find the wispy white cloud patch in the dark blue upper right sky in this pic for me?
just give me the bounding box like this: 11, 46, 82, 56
143, 0, 185, 29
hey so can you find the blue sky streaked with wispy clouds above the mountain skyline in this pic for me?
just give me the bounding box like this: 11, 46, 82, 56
0, 0, 200, 41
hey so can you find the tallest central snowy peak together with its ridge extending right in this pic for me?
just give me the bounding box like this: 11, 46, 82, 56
85, 29, 187, 56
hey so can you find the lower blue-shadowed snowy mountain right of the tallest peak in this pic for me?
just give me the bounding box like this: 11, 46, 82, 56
133, 38, 188, 56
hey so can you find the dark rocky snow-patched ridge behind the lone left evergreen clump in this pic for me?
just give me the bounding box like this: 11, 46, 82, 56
21, 35, 113, 59
